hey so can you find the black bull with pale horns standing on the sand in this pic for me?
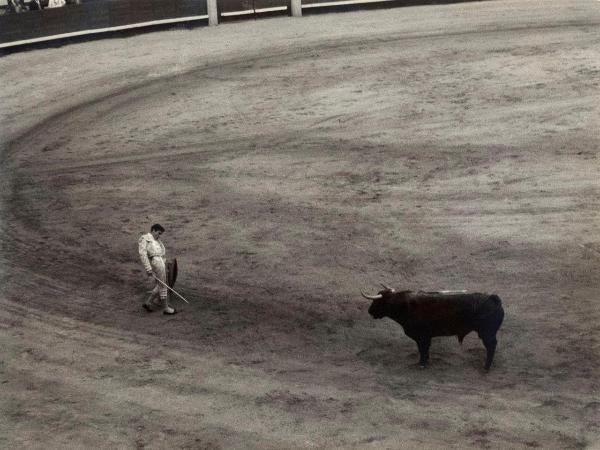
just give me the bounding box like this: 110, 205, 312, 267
363, 287, 504, 370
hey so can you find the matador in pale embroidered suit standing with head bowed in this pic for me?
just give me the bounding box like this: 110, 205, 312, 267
138, 223, 176, 314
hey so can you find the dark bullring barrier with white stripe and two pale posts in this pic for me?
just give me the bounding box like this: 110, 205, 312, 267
0, 0, 482, 49
